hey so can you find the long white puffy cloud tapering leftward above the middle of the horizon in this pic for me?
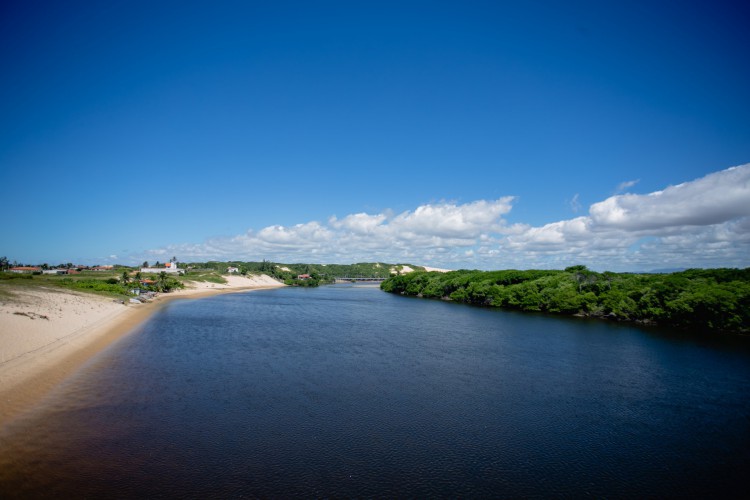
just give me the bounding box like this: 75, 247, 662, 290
148, 197, 518, 262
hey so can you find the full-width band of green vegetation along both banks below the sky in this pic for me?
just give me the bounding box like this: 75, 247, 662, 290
0, 257, 750, 333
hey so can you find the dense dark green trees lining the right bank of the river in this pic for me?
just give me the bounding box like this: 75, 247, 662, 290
381, 266, 750, 333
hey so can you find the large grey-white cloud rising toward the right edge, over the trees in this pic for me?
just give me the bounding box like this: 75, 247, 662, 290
507, 164, 750, 270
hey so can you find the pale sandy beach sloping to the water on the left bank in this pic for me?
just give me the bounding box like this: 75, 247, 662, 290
0, 275, 284, 427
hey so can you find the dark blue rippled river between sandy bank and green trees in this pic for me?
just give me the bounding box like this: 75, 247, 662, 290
0, 286, 750, 498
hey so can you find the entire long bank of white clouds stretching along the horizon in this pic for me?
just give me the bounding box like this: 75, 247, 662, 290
138, 163, 750, 271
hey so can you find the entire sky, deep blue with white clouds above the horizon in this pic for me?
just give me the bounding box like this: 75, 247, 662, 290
0, 1, 750, 270
